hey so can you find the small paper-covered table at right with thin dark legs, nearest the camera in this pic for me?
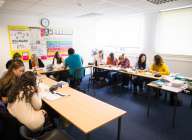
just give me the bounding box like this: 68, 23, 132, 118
147, 82, 187, 128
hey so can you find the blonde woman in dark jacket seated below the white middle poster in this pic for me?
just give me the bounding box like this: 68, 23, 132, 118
29, 54, 44, 69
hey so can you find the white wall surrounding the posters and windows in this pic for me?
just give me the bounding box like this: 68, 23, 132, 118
0, 13, 192, 76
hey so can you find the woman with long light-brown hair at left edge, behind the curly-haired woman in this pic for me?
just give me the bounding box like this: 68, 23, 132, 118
0, 60, 25, 104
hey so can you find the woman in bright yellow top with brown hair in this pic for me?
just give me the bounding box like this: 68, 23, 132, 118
150, 55, 170, 75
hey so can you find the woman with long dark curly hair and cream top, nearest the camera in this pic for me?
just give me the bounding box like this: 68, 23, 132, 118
7, 71, 46, 132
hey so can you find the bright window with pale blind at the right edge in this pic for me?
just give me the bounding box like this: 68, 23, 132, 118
156, 8, 192, 56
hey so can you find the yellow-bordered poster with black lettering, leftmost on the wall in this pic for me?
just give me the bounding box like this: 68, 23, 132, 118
8, 26, 30, 60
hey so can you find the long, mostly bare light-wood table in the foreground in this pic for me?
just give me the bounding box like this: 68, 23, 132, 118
41, 77, 126, 140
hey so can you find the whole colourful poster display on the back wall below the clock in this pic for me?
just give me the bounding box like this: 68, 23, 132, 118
8, 26, 73, 61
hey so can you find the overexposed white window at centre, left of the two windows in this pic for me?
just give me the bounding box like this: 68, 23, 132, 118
96, 15, 144, 54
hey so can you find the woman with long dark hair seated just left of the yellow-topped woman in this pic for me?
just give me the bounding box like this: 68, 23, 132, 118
133, 53, 147, 94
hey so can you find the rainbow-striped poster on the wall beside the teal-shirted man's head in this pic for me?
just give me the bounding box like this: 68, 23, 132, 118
47, 34, 72, 57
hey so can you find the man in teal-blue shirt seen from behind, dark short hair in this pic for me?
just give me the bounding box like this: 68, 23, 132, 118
65, 48, 84, 80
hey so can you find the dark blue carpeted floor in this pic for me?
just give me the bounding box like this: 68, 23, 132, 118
67, 78, 192, 140
